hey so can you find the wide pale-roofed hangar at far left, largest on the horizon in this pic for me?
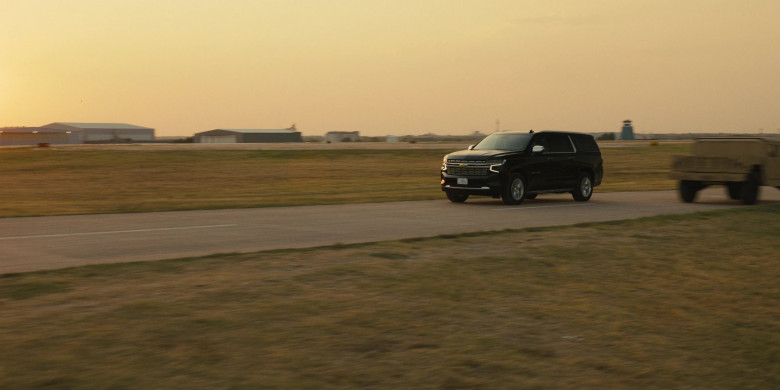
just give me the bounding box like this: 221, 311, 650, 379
42, 122, 154, 143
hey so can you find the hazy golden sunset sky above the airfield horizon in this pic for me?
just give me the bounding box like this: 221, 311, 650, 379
0, 0, 780, 136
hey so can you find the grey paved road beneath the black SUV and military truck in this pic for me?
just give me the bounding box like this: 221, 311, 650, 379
0, 187, 780, 274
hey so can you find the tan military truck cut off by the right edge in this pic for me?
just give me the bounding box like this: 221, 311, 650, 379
670, 137, 780, 205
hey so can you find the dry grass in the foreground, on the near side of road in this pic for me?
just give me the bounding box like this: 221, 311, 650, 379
0, 205, 780, 390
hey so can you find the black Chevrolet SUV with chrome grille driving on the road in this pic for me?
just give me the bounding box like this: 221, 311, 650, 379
441, 130, 604, 204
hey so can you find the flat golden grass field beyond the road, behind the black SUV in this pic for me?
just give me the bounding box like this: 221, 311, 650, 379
0, 144, 689, 217
